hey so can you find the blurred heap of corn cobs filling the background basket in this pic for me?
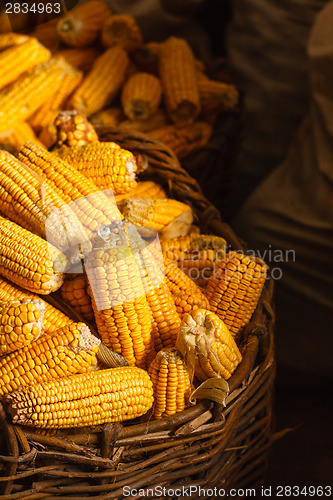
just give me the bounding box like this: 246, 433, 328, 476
0, 0, 238, 154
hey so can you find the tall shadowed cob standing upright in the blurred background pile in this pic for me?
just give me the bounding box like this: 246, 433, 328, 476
159, 37, 200, 123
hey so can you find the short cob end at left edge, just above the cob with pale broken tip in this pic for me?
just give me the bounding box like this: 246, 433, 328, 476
0, 299, 45, 356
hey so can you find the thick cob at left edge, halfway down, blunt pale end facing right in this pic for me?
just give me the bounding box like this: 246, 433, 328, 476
0, 217, 68, 295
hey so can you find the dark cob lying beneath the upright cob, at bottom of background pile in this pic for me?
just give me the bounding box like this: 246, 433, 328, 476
149, 122, 213, 158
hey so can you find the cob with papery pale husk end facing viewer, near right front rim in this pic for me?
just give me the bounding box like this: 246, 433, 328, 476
176, 309, 242, 381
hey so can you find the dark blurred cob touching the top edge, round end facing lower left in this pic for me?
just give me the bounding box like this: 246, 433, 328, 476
57, 0, 111, 47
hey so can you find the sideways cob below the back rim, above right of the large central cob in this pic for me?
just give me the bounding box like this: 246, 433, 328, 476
119, 198, 193, 238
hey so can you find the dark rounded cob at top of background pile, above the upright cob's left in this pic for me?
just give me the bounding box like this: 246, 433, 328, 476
101, 14, 143, 53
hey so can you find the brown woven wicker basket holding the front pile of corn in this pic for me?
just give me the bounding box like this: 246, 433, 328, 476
0, 127, 275, 500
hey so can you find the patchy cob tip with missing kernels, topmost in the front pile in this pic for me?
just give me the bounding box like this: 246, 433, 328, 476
54, 110, 98, 148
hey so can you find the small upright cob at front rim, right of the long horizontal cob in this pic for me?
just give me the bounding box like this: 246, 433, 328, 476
148, 348, 191, 419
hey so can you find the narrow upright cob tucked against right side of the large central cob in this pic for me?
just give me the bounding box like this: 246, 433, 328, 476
125, 223, 181, 352
